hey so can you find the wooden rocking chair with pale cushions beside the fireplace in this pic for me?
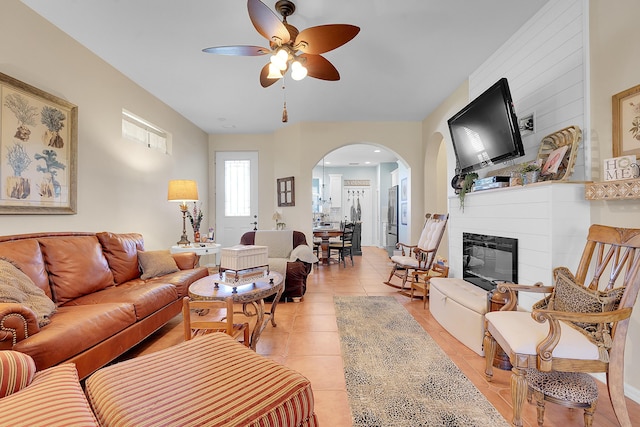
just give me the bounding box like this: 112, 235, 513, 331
384, 214, 449, 290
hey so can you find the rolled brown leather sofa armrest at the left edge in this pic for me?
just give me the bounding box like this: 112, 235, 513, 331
0, 303, 40, 350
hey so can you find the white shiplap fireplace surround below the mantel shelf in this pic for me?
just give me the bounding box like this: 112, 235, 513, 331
448, 181, 591, 308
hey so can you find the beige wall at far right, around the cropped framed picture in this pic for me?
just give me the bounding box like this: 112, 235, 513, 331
589, 0, 640, 401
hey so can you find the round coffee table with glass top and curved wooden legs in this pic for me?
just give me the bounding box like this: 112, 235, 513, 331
189, 272, 284, 351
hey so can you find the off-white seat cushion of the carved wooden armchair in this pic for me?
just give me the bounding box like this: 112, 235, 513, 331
485, 311, 600, 360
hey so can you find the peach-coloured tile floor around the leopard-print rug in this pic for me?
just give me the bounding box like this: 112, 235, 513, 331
128, 247, 640, 427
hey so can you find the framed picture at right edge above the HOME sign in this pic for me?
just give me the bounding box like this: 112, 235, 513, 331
611, 85, 640, 158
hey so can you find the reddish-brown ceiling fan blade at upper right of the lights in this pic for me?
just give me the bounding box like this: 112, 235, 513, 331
294, 24, 360, 55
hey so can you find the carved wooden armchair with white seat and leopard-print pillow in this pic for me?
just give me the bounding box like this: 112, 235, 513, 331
484, 225, 640, 427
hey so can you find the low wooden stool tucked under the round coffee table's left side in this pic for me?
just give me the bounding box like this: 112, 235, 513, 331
182, 297, 250, 347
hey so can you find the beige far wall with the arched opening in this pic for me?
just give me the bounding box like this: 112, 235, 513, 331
209, 122, 424, 239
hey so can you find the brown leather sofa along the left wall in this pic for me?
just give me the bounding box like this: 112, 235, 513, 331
0, 232, 208, 379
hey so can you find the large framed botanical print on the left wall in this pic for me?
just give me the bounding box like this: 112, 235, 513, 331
0, 73, 78, 215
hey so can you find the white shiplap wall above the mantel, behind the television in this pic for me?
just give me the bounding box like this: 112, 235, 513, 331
469, 0, 589, 181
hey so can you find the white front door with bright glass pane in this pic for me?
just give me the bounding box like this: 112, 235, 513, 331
215, 151, 258, 248
